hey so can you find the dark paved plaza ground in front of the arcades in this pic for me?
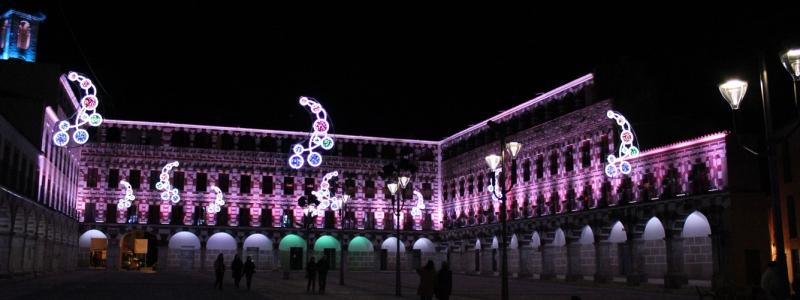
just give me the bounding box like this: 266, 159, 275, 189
0, 270, 697, 300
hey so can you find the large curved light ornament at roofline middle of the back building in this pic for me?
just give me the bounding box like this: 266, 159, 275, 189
289, 96, 333, 169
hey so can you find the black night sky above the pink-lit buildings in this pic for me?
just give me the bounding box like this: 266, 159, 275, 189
0, 0, 800, 144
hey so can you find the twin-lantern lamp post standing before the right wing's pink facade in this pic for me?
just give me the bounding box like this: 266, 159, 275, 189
486, 121, 522, 300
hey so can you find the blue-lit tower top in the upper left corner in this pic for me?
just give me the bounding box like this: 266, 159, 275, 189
0, 9, 46, 62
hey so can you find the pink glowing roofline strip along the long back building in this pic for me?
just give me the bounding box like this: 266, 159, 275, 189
103, 119, 439, 146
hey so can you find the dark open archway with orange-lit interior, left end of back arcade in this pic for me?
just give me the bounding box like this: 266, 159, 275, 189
119, 230, 158, 272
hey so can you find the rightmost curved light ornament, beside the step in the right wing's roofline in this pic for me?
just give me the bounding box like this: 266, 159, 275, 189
606, 110, 639, 177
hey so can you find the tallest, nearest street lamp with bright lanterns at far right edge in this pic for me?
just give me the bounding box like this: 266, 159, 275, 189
719, 49, 800, 296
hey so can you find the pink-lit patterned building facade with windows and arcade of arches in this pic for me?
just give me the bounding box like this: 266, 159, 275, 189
76, 74, 767, 287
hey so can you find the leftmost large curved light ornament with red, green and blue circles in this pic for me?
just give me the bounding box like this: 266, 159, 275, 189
53, 72, 103, 147
